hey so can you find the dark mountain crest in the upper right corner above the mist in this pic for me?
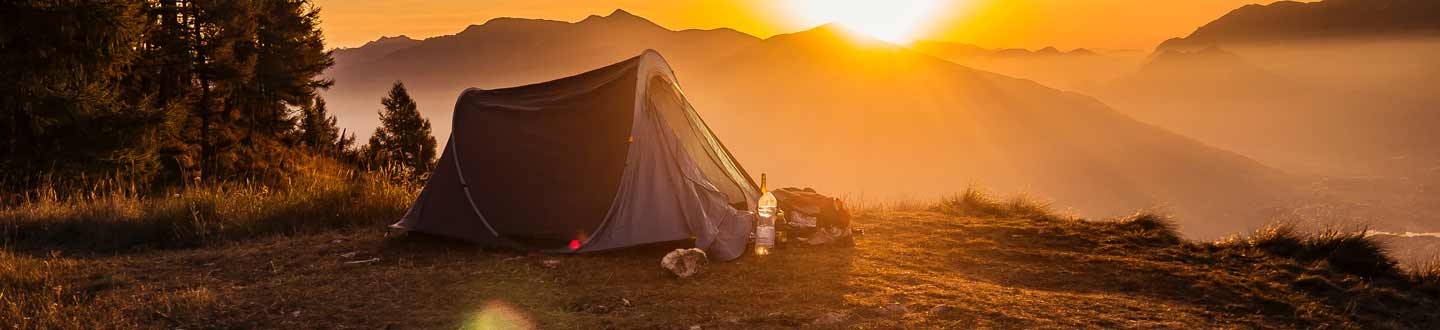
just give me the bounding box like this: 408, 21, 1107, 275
1159, 0, 1440, 49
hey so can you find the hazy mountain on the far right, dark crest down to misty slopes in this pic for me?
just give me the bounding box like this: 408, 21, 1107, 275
1080, 0, 1440, 231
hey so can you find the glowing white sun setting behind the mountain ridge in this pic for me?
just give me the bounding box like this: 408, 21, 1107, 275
785, 0, 942, 43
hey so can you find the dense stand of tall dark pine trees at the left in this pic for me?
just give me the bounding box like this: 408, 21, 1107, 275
0, 0, 334, 188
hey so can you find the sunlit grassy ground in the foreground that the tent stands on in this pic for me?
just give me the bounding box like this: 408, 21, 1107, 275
0, 187, 1440, 329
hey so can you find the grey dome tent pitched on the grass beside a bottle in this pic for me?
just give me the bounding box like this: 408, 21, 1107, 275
393, 50, 759, 259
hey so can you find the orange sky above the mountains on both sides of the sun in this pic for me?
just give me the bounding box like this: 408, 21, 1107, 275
315, 0, 1296, 49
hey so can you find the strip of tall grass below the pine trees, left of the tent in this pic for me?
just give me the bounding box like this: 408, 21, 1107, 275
0, 159, 418, 252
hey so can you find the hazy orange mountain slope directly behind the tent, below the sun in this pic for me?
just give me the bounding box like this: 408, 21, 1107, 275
327, 12, 1284, 236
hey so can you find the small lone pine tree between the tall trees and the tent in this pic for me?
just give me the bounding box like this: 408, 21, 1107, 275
366, 82, 435, 180
